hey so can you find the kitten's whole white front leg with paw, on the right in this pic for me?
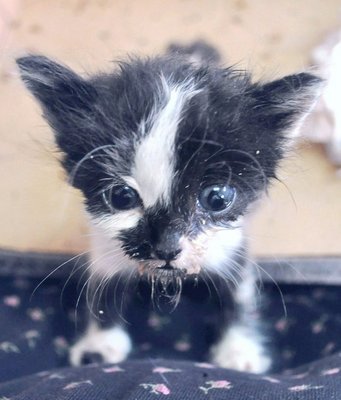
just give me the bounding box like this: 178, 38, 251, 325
211, 267, 271, 374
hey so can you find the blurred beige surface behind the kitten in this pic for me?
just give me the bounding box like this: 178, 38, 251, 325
0, 0, 341, 256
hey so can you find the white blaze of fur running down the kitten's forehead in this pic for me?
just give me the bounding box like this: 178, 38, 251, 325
128, 78, 198, 207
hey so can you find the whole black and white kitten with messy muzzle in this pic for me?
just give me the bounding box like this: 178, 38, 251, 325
17, 48, 321, 373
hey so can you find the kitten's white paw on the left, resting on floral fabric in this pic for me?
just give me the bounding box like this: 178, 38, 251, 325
69, 324, 132, 366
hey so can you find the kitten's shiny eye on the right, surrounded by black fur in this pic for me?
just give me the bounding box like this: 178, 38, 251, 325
199, 185, 236, 212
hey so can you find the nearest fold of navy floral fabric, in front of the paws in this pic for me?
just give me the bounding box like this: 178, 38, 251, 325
0, 354, 341, 400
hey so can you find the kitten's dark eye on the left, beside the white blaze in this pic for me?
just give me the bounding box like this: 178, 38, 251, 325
103, 186, 140, 210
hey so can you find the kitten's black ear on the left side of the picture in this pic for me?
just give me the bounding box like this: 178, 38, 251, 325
16, 55, 96, 127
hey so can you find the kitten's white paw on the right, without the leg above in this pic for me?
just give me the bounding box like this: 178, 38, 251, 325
212, 326, 271, 374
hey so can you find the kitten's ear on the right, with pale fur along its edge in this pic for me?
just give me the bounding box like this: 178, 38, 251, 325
251, 73, 323, 143
